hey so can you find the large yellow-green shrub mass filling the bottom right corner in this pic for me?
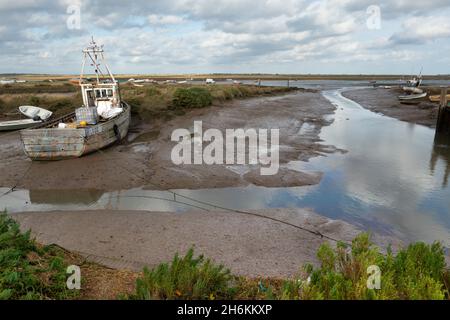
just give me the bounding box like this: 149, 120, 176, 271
279, 234, 449, 300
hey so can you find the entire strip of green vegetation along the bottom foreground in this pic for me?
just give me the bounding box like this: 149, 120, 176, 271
0, 214, 450, 300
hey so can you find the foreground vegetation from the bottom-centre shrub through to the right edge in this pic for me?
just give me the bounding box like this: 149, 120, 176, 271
124, 233, 450, 300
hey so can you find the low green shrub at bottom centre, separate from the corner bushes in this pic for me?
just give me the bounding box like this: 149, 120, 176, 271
130, 248, 234, 300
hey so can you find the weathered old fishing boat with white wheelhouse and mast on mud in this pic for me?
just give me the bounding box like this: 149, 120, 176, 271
20, 40, 130, 160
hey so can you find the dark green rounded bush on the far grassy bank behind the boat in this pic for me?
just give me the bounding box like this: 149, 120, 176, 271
172, 87, 213, 108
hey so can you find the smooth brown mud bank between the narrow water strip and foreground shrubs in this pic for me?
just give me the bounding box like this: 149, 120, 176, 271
12, 209, 400, 277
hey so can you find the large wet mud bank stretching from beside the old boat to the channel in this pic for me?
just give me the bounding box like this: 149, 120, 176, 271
0, 92, 336, 191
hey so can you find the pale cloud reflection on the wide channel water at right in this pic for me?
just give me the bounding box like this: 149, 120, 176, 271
317, 90, 450, 245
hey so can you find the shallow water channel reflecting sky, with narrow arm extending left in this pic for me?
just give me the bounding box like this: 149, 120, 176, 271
0, 88, 450, 247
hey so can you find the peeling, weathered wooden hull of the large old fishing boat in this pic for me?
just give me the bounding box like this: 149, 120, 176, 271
20, 102, 130, 161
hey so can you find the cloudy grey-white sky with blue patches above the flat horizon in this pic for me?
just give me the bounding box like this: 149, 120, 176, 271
0, 0, 450, 74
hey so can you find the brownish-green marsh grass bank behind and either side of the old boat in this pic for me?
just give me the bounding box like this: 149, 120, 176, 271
0, 82, 293, 121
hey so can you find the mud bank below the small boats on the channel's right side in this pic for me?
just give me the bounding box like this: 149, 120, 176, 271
342, 88, 438, 128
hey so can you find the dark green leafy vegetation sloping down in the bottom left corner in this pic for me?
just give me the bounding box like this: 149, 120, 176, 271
0, 214, 76, 300
